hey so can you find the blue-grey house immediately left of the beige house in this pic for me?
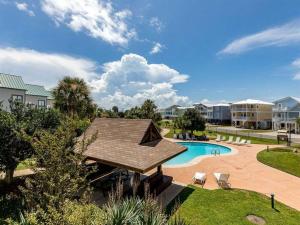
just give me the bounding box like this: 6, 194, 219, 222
207, 103, 231, 124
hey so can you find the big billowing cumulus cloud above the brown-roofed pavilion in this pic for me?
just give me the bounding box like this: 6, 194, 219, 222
93, 54, 189, 108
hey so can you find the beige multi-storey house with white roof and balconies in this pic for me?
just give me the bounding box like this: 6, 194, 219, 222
231, 99, 273, 129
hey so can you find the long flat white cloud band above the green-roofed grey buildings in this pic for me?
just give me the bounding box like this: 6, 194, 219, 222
0, 48, 97, 88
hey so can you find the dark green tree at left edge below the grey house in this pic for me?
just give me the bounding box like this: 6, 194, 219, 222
0, 111, 33, 184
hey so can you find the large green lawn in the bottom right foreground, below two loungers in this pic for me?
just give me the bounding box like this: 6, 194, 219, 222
168, 186, 300, 225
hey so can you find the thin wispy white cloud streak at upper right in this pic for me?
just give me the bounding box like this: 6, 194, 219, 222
218, 20, 300, 54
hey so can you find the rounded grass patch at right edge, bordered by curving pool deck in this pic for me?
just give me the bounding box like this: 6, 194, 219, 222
257, 148, 300, 177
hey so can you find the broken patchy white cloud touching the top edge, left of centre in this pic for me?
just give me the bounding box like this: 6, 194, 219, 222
41, 0, 136, 45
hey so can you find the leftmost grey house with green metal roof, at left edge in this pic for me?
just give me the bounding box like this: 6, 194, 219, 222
0, 73, 27, 111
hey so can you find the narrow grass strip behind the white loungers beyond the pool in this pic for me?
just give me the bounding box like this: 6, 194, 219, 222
165, 129, 278, 145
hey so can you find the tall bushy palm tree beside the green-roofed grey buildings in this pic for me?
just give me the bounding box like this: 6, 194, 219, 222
53, 76, 96, 118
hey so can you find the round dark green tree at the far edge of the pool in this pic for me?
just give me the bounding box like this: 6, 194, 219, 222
182, 109, 205, 133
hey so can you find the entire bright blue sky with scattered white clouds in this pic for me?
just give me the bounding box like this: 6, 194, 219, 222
0, 0, 300, 109
